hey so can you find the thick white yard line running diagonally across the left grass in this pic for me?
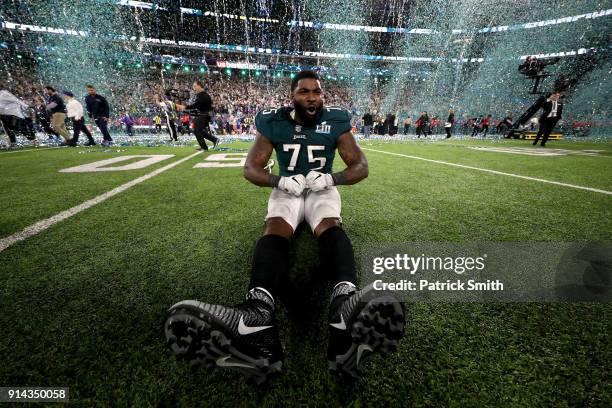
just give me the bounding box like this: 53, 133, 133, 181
0, 151, 202, 252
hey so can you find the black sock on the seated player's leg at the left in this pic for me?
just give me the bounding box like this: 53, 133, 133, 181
249, 235, 289, 297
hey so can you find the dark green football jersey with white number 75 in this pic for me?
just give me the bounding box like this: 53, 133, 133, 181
255, 106, 351, 176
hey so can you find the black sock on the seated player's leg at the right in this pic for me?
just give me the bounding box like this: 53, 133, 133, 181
319, 227, 356, 286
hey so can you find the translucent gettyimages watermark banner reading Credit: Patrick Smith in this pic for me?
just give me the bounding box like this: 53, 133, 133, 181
360, 242, 612, 302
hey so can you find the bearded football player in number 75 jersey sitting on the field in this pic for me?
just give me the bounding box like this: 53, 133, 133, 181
164, 71, 404, 383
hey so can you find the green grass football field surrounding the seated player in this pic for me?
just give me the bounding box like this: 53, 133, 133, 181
0, 139, 612, 407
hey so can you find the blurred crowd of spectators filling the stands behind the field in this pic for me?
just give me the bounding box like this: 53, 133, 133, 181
0, 72, 604, 145
